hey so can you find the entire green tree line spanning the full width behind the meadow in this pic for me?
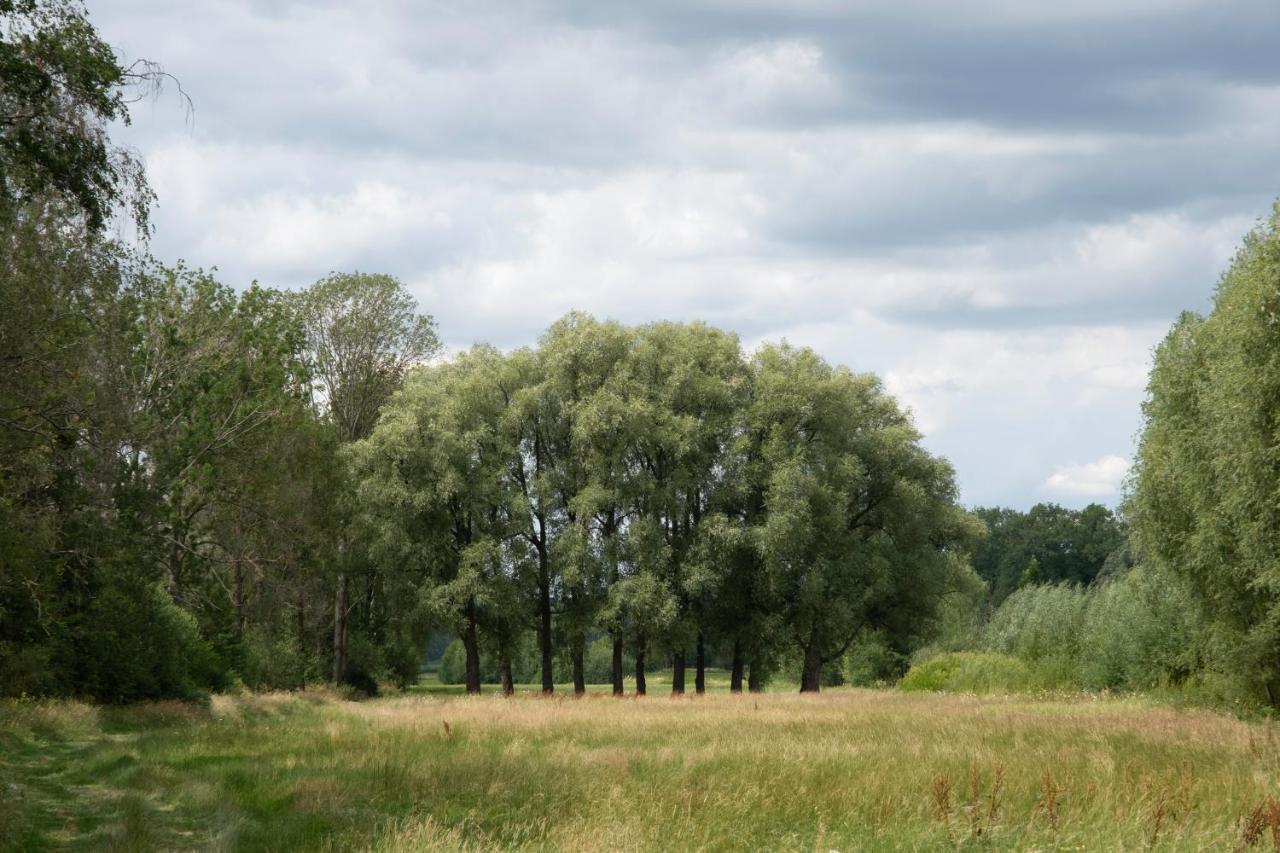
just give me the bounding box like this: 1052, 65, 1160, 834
0, 0, 1280, 706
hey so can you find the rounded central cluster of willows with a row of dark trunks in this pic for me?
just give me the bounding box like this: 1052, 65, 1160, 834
351, 314, 974, 693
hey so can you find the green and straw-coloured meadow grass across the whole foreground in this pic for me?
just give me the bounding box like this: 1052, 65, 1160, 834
0, 690, 1280, 850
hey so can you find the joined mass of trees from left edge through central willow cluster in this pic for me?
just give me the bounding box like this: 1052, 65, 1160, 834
0, 0, 975, 701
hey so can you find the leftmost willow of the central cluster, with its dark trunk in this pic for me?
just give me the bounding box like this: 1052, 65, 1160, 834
351, 347, 521, 693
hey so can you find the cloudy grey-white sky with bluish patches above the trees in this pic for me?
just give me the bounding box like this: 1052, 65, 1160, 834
88, 0, 1280, 508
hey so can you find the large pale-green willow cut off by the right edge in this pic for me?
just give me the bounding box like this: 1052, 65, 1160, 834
1130, 205, 1280, 707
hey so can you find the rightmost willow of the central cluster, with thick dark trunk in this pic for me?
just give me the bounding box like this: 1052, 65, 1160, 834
746, 346, 972, 692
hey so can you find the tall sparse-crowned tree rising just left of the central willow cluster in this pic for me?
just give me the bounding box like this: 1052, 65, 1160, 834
301, 273, 440, 683
